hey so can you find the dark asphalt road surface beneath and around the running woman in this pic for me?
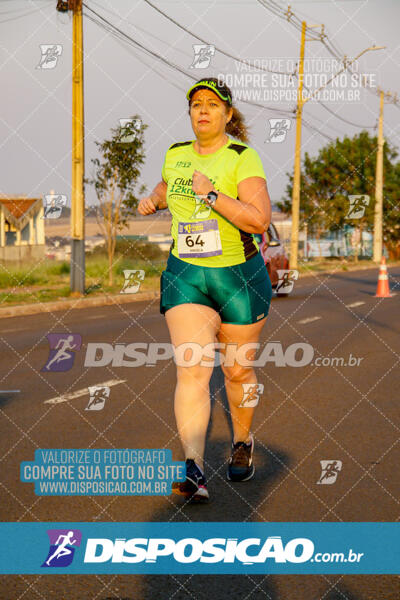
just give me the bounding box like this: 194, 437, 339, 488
0, 268, 400, 600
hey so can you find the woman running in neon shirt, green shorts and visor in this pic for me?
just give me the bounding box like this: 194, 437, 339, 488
138, 78, 272, 501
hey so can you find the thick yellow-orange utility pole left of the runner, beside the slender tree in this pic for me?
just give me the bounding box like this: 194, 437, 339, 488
57, 0, 85, 295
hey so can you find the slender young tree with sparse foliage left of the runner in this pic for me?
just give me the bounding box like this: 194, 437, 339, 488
85, 115, 147, 285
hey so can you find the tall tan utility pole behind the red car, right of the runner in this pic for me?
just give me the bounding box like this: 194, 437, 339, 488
290, 21, 307, 269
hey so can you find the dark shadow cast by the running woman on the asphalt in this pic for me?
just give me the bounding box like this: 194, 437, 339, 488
118, 367, 289, 600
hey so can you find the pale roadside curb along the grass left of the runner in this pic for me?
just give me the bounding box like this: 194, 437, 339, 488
0, 292, 160, 319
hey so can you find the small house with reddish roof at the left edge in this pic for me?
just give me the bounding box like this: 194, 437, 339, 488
0, 196, 45, 260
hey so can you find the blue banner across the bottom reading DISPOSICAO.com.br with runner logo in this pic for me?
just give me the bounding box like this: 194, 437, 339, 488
0, 522, 400, 575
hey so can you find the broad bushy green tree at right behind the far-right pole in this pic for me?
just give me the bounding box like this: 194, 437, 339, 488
278, 131, 400, 257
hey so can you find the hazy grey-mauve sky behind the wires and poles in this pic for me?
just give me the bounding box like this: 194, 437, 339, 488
0, 0, 400, 204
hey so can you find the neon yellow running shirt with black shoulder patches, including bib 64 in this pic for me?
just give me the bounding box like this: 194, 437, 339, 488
162, 139, 266, 267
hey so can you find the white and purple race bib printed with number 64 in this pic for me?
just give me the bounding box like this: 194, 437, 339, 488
178, 219, 222, 258
